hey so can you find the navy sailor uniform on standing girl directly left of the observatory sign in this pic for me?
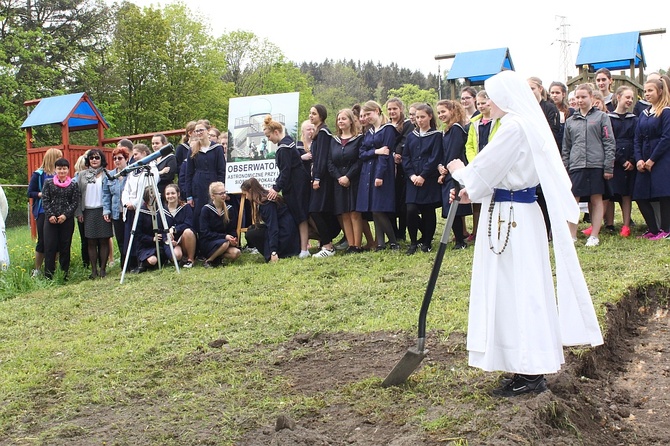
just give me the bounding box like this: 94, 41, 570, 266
185, 143, 226, 229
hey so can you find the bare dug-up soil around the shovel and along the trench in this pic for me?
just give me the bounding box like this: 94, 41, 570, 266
237, 287, 670, 446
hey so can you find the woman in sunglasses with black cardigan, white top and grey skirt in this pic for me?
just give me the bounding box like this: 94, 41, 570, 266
77, 149, 112, 279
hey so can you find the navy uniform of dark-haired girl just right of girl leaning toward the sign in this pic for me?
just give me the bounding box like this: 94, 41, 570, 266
309, 126, 333, 213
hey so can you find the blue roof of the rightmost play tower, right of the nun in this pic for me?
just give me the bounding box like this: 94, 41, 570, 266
575, 31, 647, 71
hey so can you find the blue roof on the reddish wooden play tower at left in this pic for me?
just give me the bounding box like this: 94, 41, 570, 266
21, 93, 109, 130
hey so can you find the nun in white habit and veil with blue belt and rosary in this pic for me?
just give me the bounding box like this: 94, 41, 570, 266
447, 71, 603, 396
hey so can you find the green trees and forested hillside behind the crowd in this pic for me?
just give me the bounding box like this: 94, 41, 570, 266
0, 0, 438, 221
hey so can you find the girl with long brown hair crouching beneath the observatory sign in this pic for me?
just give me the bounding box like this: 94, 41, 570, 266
240, 177, 300, 262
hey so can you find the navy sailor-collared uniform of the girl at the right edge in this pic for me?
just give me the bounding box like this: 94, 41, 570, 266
633, 107, 670, 200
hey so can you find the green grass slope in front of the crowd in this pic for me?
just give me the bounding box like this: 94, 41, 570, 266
0, 215, 670, 445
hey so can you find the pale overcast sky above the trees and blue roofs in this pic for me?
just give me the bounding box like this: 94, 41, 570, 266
113, 0, 670, 90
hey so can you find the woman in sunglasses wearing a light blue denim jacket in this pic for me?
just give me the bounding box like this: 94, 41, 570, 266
102, 145, 130, 265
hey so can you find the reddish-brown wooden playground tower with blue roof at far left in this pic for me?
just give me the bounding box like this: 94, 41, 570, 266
21, 93, 185, 237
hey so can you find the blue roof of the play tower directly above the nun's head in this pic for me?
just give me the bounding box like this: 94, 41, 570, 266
447, 48, 514, 83
